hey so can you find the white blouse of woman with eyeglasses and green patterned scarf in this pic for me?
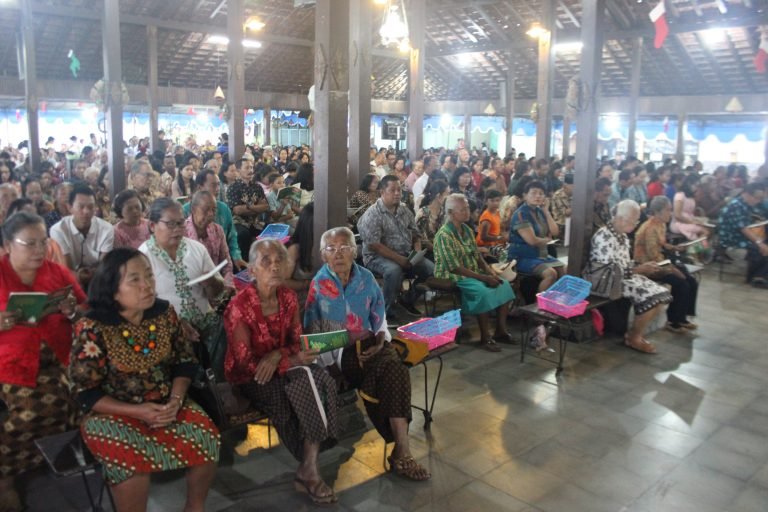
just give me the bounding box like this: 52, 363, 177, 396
139, 237, 215, 319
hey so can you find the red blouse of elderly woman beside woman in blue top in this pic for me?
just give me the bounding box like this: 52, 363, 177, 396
224, 286, 302, 384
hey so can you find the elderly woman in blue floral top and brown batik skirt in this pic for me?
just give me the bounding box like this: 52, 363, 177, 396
304, 228, 431, 480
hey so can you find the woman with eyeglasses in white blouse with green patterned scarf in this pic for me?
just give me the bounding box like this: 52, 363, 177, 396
139, 197, 224, 350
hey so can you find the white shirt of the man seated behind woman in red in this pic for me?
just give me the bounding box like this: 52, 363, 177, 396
51, 215, 115, 270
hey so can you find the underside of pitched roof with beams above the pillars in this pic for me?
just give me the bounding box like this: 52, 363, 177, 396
0, 0, 768, 101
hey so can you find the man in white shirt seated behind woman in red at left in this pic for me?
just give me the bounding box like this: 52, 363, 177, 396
51, 185, 115, 288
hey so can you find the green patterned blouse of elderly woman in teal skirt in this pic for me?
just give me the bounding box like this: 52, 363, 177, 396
433, 222, 480, 282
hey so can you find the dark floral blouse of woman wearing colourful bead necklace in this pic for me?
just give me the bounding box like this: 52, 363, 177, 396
69, 299, 197, 411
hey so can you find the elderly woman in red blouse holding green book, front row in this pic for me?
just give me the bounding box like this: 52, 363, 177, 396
224, 239, 338, 505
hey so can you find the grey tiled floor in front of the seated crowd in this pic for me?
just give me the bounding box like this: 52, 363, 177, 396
21, 271, 768, 512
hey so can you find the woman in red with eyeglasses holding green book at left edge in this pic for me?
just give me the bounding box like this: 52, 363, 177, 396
0, 212, 86, 510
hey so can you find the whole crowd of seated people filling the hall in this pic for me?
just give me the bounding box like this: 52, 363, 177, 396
0, 136, 768, 511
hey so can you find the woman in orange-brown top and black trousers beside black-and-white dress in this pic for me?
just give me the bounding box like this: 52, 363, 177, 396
634, 196, 699, 334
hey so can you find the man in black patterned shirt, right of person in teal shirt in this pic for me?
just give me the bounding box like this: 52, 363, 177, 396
227, 158, 269, 262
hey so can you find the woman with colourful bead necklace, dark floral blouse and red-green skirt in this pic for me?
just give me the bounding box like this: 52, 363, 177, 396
69, 249, 220, 512
